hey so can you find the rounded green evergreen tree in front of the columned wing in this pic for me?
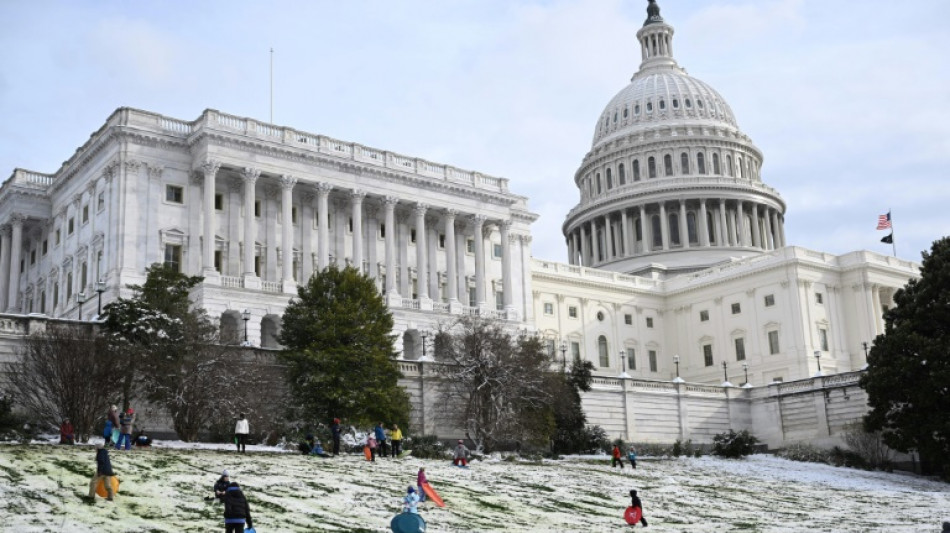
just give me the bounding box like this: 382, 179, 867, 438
279, 266, 409, 427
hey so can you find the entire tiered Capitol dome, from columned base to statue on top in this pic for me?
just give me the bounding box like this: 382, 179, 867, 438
563, 0, 785, 275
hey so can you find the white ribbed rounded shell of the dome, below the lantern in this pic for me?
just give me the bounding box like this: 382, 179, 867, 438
592, 67, 738, 148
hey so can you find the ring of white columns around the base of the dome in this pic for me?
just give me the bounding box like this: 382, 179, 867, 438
567, 198, 785, 266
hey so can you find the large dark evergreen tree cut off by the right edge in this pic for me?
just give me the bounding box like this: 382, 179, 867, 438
861, 237, 950, 478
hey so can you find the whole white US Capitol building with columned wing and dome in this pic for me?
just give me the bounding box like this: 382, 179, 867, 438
0, 0, 919, 440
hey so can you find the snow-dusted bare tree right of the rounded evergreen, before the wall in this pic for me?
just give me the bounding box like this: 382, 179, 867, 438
436, 318, 554, 451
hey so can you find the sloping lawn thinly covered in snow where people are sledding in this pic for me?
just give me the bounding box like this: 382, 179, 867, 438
0, 444, 950, 533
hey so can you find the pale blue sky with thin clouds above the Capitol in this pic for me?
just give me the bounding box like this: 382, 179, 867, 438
0, 0, 950, 261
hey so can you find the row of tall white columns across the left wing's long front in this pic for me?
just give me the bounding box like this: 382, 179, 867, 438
201, 161, 513, 309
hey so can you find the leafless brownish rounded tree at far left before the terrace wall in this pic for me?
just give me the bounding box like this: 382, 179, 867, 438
10, 324, 122, 441
